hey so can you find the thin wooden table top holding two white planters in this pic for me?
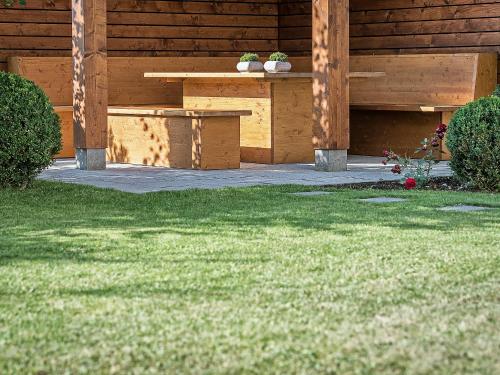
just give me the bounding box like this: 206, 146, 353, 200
144, 72, 385, 80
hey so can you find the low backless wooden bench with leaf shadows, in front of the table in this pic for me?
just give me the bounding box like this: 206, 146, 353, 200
107, 107, 252, 169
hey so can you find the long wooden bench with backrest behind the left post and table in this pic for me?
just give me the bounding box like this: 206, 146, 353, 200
8, 57, 248, 166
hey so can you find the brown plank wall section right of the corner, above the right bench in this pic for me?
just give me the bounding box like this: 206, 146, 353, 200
279, 0, 500, 82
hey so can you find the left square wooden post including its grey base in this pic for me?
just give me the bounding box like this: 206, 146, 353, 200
72, 0, 108, 170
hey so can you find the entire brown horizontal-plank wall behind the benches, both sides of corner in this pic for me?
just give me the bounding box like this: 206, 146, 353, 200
0, 0, 500, 82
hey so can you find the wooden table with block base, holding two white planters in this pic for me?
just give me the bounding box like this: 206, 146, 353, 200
144, 72, 385, 164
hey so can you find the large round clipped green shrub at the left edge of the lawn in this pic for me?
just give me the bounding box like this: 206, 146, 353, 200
0, 72, 61, 188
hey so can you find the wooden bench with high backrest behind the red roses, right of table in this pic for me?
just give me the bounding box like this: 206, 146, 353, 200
350, 53, 497, 159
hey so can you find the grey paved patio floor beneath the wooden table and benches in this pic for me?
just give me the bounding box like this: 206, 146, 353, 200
39, 156, 451, 194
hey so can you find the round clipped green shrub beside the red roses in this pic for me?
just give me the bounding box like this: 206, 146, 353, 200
446, 96, 500, 191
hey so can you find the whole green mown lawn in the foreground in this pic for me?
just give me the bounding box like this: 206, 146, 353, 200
0, 182, 500, 374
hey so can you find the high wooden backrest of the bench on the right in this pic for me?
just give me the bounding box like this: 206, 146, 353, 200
350, 53, 497, 110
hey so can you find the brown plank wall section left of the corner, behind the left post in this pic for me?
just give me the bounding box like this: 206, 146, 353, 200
0, 0, 278, 69
